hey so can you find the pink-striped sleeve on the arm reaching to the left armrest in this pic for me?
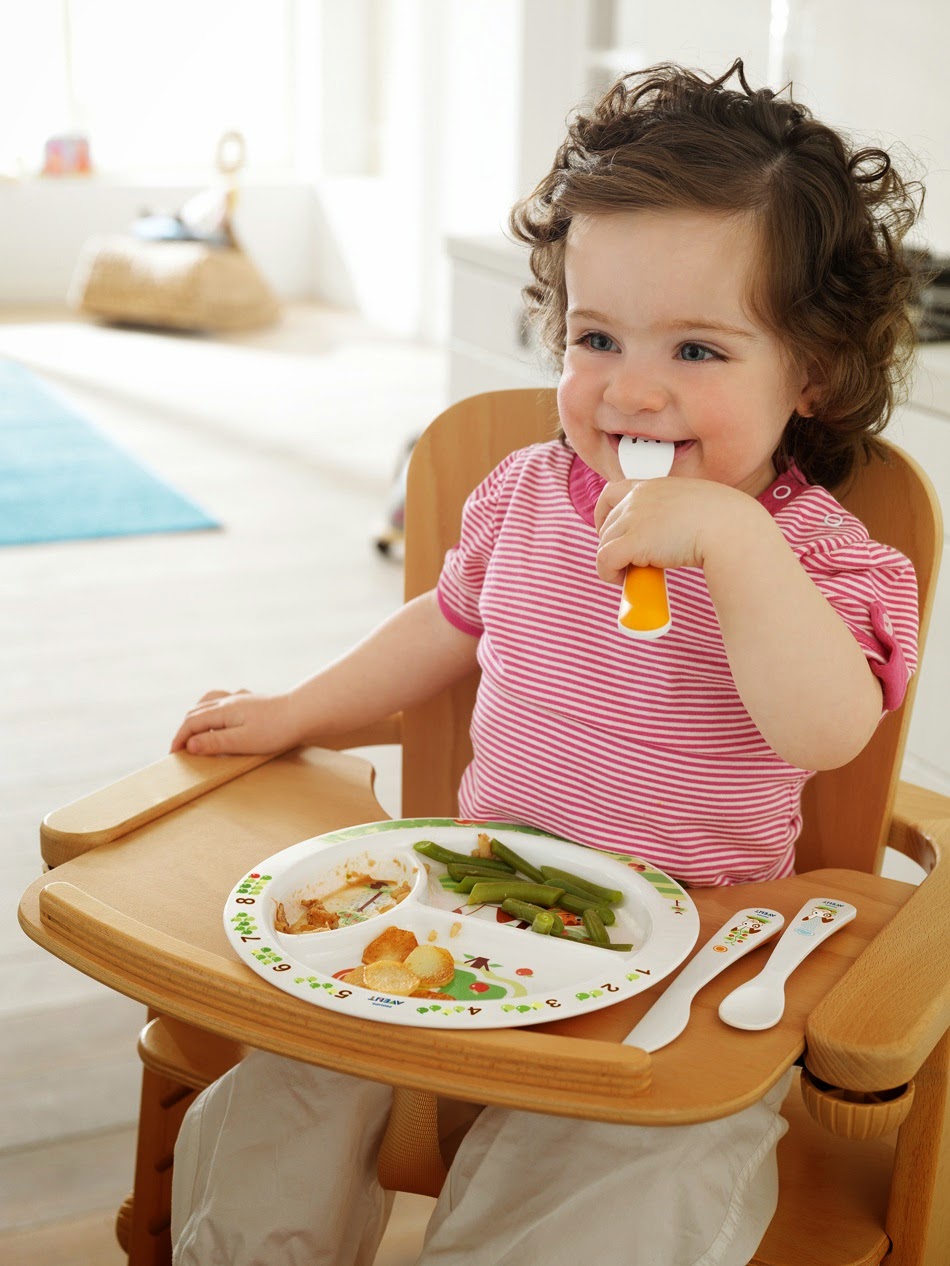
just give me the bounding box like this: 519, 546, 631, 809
436, 453, 518, 637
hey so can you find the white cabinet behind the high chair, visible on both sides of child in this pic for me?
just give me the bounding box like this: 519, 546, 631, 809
448, 237, 950, 794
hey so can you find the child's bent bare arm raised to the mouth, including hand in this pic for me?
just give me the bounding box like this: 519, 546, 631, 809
598, 479, 882, 770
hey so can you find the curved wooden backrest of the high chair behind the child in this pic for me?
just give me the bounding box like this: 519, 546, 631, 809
403, 389, 942, 872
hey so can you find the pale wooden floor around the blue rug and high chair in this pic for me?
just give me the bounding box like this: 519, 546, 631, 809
0, 306, 445, 1266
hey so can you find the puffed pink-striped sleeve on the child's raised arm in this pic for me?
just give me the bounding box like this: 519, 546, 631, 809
797, 533, 918, 711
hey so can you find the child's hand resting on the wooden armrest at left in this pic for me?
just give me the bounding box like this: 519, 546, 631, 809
170, 690, 299, 756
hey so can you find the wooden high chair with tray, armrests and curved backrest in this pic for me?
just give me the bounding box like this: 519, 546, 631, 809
20, 390, 950, 1266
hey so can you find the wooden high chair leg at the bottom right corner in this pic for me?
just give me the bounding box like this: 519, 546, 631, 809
885, 1033, 950, 1266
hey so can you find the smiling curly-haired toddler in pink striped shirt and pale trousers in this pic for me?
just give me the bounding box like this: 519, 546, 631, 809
172, 62, 917, 1266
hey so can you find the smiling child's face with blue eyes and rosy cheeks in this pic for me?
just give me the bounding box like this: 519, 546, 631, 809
557, 211, 811, 496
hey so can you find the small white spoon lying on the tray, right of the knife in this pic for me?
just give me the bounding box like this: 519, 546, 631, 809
719, 896, 858, 1029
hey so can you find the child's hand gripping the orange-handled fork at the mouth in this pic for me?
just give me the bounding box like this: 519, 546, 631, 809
594, 479, 763, 585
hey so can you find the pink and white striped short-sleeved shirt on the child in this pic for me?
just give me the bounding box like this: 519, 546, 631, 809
438, 442, 917, 885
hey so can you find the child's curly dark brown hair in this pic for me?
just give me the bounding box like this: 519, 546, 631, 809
510, 58, 923, 487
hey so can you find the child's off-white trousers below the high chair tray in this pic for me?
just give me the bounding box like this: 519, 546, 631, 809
172, 1052, 790, 1266
